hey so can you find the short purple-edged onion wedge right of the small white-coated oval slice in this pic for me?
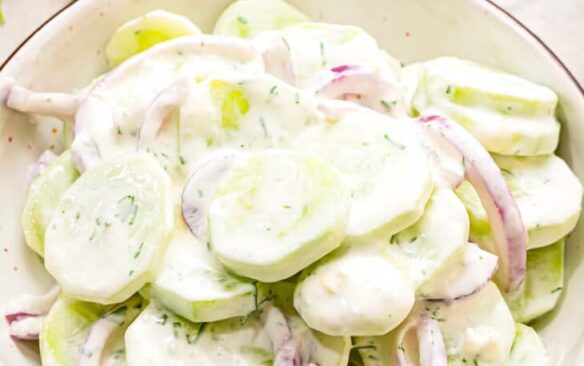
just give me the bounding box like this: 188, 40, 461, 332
418, 243, 498, 301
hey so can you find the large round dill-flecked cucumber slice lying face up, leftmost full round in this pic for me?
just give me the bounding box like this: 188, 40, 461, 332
45, 155, 174, 304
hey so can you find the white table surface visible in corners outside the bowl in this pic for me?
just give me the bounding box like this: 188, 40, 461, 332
0, 0, 584, 85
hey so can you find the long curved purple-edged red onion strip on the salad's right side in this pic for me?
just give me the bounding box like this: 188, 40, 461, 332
418, 115, 527, 293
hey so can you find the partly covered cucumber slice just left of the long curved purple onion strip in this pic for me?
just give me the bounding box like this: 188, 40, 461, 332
388, 188, 469, 287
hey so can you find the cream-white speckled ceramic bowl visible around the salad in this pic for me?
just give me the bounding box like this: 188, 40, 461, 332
0, 0, 584, 366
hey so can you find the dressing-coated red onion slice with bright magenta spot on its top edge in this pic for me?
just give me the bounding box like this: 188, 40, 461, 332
314, 65, 404, 116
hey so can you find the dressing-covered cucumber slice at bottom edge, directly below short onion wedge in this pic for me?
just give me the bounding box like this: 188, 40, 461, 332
422, 282, 515, 366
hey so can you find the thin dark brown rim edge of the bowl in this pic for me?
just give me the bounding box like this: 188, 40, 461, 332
0, 0, 584, 102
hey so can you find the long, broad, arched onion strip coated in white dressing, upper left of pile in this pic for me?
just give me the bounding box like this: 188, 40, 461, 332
71, 35, 263, 171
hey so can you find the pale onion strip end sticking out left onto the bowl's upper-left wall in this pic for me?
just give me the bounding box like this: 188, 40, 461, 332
6, 86, 80, 119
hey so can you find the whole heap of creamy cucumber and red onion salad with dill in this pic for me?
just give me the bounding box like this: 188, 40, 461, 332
5, 0, 582, 366
